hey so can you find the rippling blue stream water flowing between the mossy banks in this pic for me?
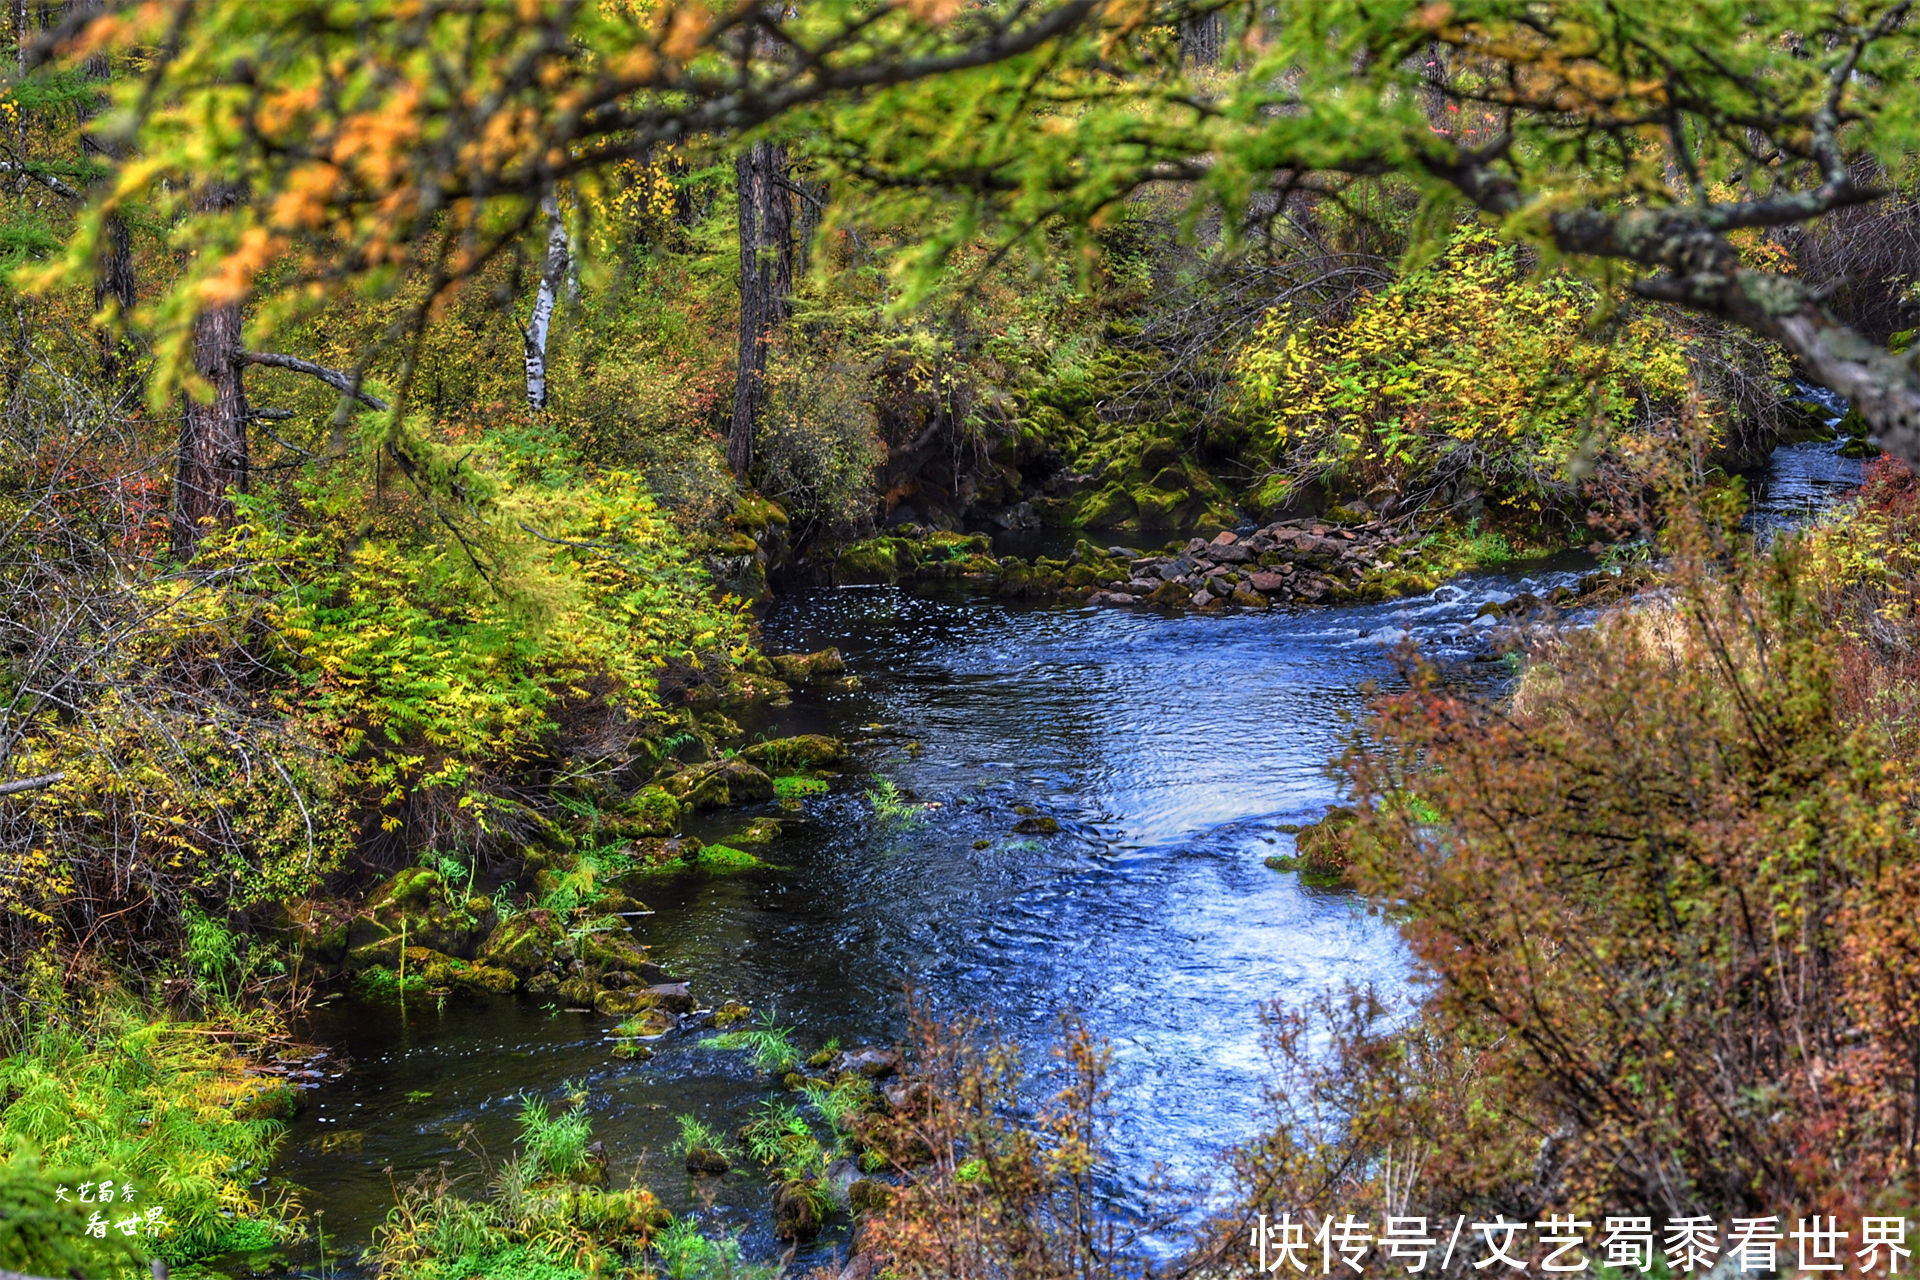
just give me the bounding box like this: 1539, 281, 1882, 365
275, 445, 1859, 1267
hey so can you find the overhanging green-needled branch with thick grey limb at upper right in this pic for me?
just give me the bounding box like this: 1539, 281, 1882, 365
833, 0, 1920, 464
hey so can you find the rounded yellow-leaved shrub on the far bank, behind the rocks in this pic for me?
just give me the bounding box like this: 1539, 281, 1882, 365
1238, 226, 1786, 526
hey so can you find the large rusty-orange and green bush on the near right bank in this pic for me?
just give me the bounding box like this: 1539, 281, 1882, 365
1240, 472, 1920, 1243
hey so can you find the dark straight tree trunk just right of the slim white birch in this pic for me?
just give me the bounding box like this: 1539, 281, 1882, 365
726, 142, 793, 478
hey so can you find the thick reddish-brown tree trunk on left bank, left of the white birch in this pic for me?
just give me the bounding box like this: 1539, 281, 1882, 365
173, 182, 248, 560
